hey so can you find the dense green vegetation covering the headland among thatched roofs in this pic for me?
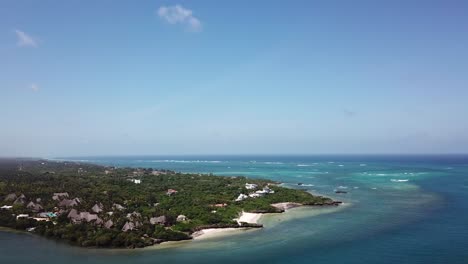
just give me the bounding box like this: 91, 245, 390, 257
0, 159, 334, 247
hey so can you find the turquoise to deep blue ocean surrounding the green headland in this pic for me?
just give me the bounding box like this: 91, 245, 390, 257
0, 155, 468, 264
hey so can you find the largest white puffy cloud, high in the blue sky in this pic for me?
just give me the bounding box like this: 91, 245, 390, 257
157, 5, 202, 32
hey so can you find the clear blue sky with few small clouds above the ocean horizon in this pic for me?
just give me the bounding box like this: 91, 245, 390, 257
0, 0, 468, 157
